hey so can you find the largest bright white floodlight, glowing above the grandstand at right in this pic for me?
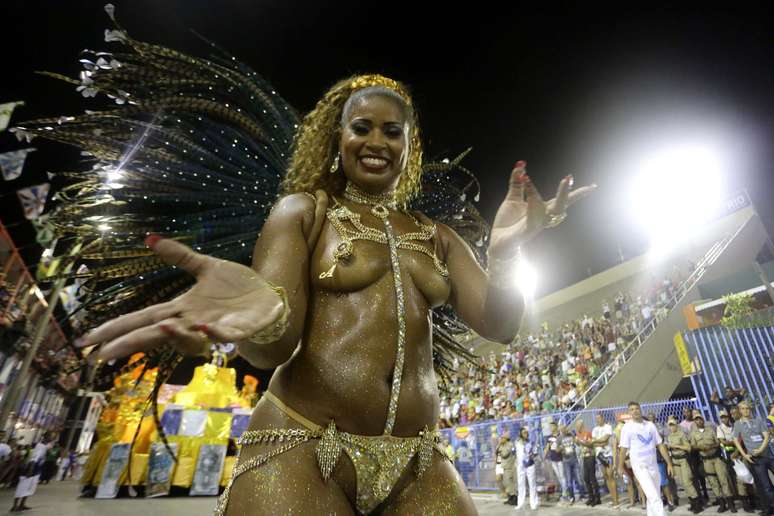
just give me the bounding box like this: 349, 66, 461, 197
632, 145, 723, 251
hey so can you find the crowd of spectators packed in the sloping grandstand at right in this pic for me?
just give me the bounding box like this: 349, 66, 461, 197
441, 263, 695, 427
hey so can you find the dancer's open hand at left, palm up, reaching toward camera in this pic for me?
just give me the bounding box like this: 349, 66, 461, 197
81, 235, 285, 360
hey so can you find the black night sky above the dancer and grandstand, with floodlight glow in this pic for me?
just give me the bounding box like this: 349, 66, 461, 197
0, 0, 774, 382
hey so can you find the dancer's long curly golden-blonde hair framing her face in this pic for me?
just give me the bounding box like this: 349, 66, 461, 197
282, 75, 422, 207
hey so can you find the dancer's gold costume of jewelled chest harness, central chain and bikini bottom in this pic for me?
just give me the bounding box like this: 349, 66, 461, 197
215, 185, 449, 516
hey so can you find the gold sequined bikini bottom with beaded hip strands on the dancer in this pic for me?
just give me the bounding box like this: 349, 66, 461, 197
215, 391, 448, 516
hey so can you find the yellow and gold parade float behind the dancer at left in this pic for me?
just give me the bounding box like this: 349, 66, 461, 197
81, 353, 258, 498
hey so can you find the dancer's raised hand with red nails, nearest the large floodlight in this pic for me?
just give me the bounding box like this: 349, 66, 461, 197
489, 161, 597, 260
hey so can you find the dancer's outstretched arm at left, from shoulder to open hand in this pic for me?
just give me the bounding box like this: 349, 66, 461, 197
82, 194, 314, 367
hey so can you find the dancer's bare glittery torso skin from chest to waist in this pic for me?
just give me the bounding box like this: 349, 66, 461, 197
251, 200, 449, 436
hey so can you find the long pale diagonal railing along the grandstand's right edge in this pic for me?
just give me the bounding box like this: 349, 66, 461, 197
568, 232, 742, 412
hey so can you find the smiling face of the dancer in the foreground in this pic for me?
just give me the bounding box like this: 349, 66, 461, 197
339, 94, 409, 194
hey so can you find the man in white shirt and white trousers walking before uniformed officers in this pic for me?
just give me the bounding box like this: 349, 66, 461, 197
618, 401, 672, 516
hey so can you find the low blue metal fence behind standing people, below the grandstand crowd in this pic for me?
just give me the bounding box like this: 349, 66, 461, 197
441, 398, 709, 491
